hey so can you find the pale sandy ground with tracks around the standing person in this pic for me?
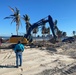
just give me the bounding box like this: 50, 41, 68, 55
0, 42, 76, 75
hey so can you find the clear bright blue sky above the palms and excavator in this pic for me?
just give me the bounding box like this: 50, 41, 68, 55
0, 0, 76, 36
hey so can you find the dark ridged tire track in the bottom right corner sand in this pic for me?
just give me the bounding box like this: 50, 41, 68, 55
50, 62, 76, 75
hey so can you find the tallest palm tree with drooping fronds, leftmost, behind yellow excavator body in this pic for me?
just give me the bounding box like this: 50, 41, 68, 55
4, 6, 20, 35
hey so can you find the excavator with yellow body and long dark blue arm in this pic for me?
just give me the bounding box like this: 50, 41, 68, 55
9, 15, 58, 44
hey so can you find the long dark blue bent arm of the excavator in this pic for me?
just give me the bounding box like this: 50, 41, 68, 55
24, 15, 56, 40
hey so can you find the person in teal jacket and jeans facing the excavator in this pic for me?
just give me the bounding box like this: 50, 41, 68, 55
14, 41, 24, 68
